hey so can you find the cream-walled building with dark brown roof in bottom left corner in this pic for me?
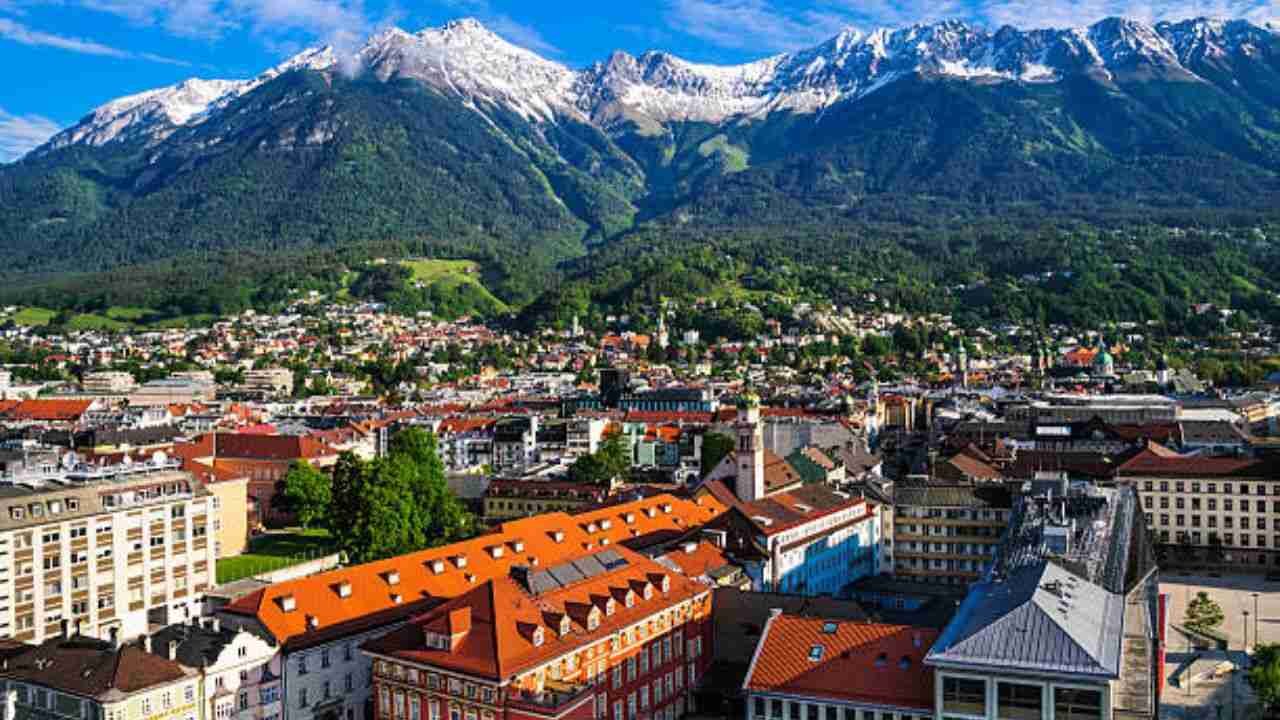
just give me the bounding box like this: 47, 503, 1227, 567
0, 637, 207, 720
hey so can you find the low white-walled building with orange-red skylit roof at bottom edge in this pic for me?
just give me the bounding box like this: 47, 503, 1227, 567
742, 610, 938, 720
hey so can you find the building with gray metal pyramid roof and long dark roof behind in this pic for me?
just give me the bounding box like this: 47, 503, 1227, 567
925, 483, 1164, 720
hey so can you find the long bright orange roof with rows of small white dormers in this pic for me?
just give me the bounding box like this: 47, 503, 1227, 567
215, 495, 724, 644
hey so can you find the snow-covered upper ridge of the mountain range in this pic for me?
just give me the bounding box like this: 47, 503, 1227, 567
35, 18, 1275, 154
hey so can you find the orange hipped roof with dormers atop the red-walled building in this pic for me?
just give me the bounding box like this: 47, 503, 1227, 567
365, 548, 710, 680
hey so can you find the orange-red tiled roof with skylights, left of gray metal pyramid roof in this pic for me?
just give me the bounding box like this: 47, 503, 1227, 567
744, 615, 938, 710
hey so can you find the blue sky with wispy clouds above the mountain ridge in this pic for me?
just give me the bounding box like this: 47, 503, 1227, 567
0, 0, 1280, 161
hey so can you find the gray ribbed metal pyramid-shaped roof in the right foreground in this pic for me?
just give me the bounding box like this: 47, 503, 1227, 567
925, 560, 1124, 678
